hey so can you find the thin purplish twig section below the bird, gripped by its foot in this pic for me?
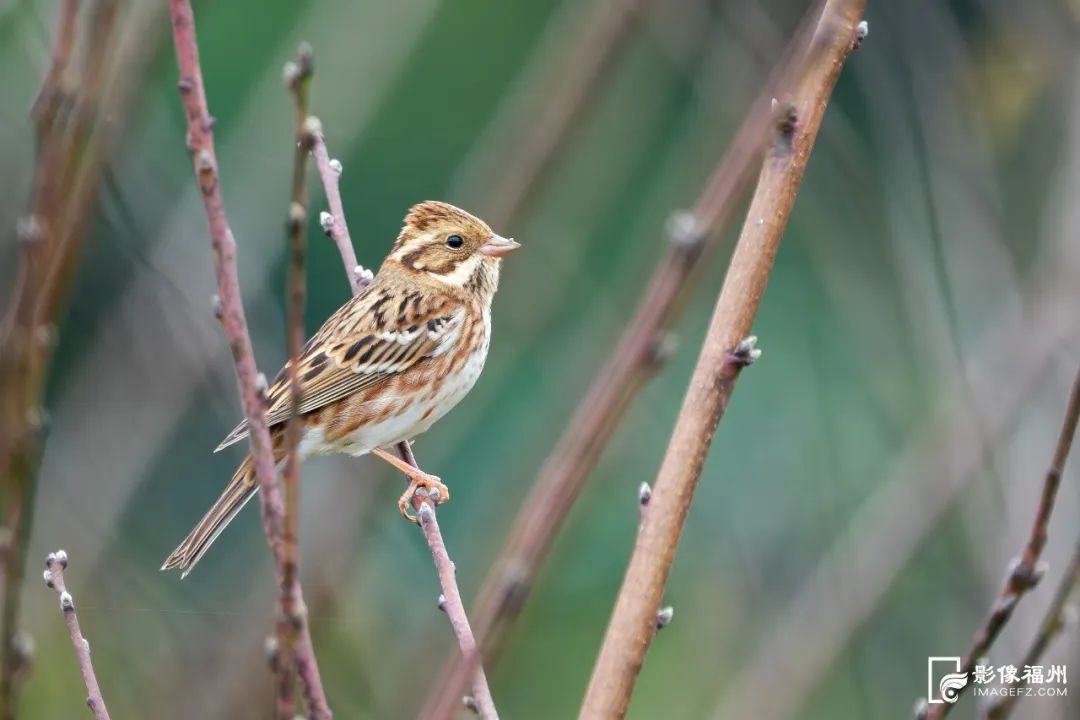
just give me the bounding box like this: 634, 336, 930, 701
397, 441, 499, 720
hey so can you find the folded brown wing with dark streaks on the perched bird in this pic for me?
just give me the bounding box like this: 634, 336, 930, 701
215, 284, 464, 452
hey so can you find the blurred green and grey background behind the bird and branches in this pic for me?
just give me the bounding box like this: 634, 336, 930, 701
0, 0, 1080, 719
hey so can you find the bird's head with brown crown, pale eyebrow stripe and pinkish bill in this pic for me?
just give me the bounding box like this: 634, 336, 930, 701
388, 200, 521, 293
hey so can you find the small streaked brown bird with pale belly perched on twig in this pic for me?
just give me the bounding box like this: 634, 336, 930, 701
161, 201, 521, 576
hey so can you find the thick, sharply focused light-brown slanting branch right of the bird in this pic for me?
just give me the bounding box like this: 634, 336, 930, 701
579, 0, 864, 718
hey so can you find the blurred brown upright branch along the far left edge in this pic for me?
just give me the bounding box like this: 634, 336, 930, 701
0, 0, 121, 720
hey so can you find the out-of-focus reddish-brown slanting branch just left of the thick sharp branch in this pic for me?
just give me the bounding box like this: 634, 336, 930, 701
423, 1, 816, 718
